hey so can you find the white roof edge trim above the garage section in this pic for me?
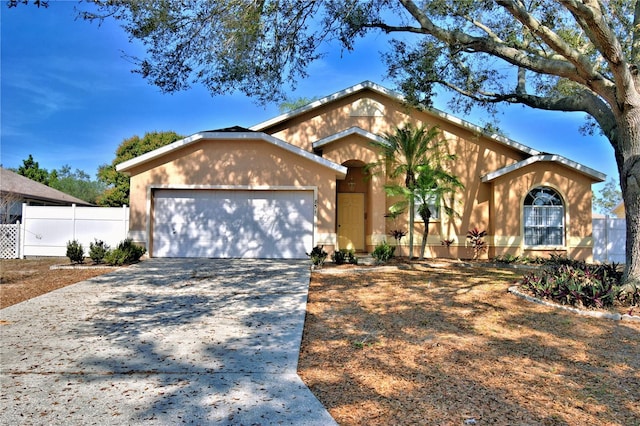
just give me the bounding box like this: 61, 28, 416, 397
116, 128, 347, 177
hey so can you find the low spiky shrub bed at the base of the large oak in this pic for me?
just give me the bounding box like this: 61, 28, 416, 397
522, 259, 622, 308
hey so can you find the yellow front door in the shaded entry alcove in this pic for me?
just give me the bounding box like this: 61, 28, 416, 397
338, 193, 364, 251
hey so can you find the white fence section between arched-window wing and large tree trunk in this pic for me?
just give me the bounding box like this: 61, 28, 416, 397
592, 217, 627, 263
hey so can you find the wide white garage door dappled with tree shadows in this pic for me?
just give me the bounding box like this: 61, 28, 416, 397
152, 189, 314, 259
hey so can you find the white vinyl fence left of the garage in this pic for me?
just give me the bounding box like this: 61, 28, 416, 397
3, 204, 129, 258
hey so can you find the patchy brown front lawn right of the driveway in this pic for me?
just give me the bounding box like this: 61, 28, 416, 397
299, 262, 640, 425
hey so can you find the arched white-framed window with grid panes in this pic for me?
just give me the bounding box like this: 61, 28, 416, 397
524, 186, 564, 246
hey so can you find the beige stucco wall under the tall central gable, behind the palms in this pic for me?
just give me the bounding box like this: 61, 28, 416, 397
264, 90, 540, 257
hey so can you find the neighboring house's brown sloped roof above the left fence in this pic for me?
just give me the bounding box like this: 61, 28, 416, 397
0, 167, 92, 206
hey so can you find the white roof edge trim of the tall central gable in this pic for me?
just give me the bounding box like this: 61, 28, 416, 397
250, 81, 540, 155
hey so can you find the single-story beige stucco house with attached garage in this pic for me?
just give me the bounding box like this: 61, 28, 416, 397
117, 82, 605, 259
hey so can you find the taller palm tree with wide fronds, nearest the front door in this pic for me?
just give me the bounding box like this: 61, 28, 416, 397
369, 123, 440, 258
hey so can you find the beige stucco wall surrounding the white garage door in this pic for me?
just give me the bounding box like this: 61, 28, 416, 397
129, 140, 336, 253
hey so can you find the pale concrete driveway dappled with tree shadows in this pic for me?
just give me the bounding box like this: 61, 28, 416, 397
0, 259, 335, 425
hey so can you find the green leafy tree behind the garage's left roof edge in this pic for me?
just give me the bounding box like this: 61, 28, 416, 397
96, 131, 183, 207
